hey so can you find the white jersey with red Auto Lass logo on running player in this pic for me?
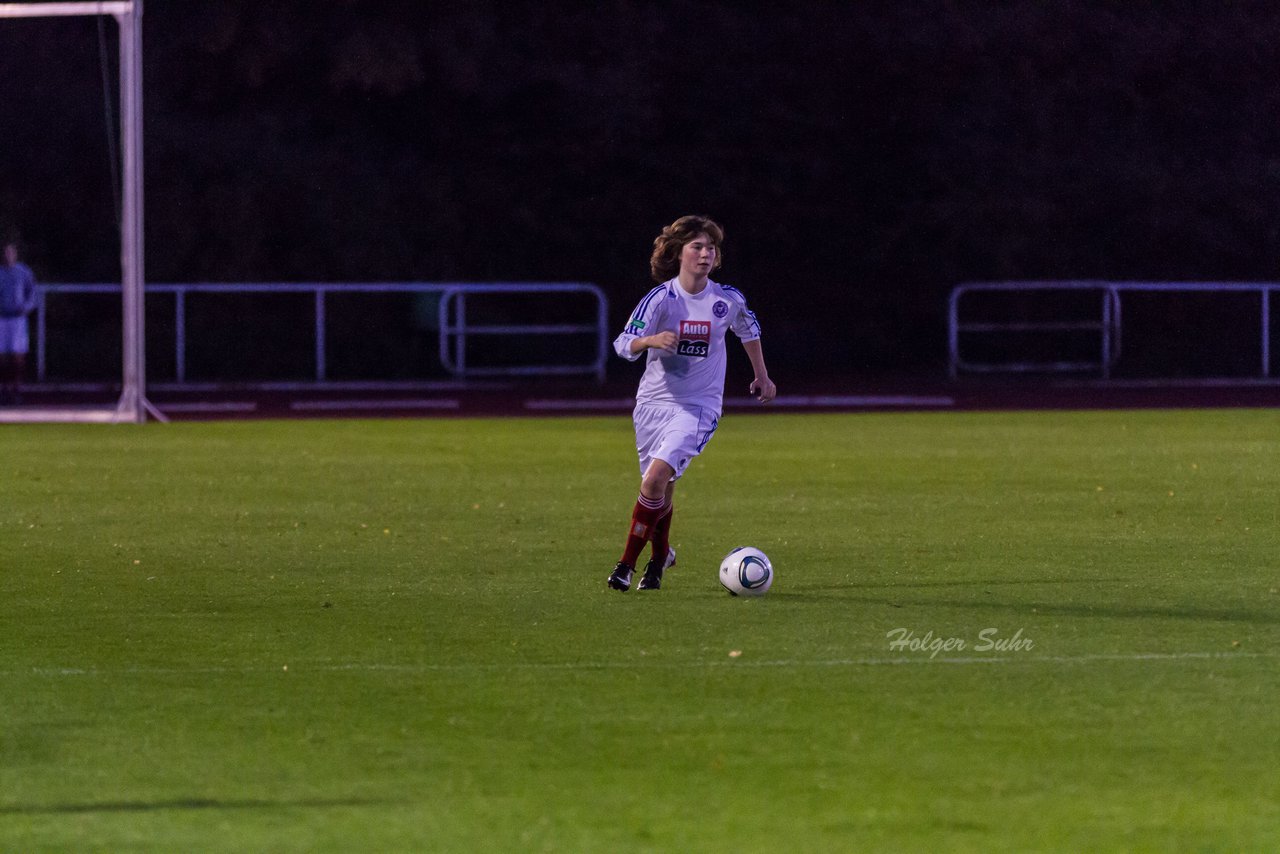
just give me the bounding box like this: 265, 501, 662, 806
613, 279, 760, 415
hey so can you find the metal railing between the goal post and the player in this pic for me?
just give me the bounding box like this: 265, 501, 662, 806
36, 282, 609, 388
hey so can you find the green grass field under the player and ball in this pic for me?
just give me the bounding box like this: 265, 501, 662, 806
0, 410, 1280, 851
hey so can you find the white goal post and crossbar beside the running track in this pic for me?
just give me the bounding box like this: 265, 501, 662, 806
0, 0, 168, 424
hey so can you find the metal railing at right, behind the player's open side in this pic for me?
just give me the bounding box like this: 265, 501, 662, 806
947, 282, 1280, 379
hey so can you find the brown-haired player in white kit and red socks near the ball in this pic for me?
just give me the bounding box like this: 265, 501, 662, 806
608, 216, 777, 590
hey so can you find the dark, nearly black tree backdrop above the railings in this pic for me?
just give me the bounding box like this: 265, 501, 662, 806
0, 0, 1280, 375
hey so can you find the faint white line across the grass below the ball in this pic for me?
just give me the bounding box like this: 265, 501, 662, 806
12, 652, 1280, 676
